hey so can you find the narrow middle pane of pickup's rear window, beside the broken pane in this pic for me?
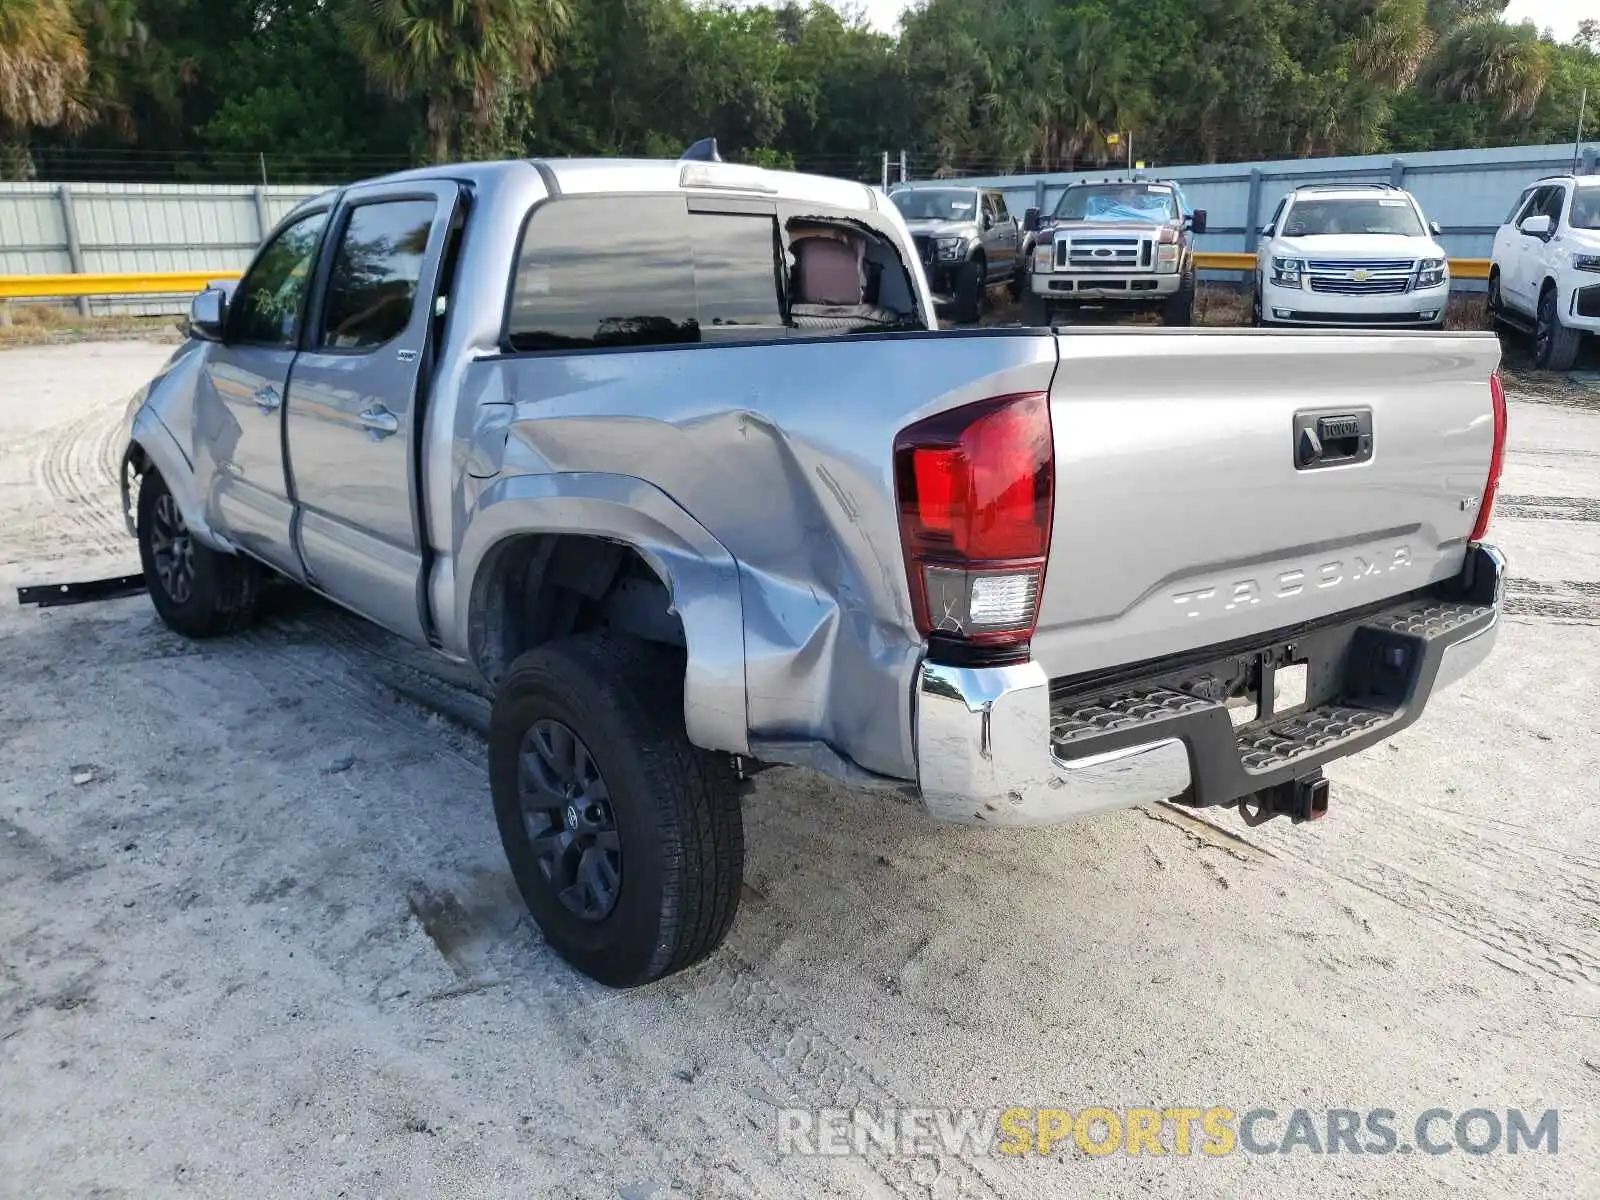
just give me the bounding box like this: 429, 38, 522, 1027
690, 213, 784, 336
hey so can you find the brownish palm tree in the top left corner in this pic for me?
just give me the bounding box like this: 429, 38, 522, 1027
0, 0, 90, 179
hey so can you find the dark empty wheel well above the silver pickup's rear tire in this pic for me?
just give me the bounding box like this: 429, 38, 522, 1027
467, 533, 685, 683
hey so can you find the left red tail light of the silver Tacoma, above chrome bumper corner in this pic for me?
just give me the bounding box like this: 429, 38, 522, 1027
894, 392, 1056, 646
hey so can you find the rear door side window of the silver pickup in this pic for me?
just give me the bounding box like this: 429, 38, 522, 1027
318, 200, 435, 350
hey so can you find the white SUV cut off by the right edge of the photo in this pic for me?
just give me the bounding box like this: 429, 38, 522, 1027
1488, 174, 1600, 371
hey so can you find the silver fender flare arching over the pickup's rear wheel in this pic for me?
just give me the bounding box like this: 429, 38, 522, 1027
453, 472, 750, 754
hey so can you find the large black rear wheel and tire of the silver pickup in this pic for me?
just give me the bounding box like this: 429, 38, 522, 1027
490, 632, 744, 987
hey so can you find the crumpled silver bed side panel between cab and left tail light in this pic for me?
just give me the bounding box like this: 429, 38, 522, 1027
485, 330, 1056, 779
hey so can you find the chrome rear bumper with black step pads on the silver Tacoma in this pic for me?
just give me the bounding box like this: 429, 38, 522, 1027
915, 546, 1506, 826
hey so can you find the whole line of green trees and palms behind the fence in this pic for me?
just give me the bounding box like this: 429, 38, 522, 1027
0, 0, 1600, 182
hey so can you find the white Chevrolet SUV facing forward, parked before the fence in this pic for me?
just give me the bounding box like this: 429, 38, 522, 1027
1250, 184, 1450, 330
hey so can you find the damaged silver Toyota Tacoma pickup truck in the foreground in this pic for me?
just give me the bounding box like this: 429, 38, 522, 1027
123, 162, 1506, 986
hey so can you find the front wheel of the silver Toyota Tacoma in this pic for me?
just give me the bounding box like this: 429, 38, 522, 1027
136, 469, 261, 638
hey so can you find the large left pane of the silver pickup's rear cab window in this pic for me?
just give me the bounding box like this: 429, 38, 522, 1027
506, 195, 699, 350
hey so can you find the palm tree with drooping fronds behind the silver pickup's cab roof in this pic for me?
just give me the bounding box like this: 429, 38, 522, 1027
342, 0, 571, 162
